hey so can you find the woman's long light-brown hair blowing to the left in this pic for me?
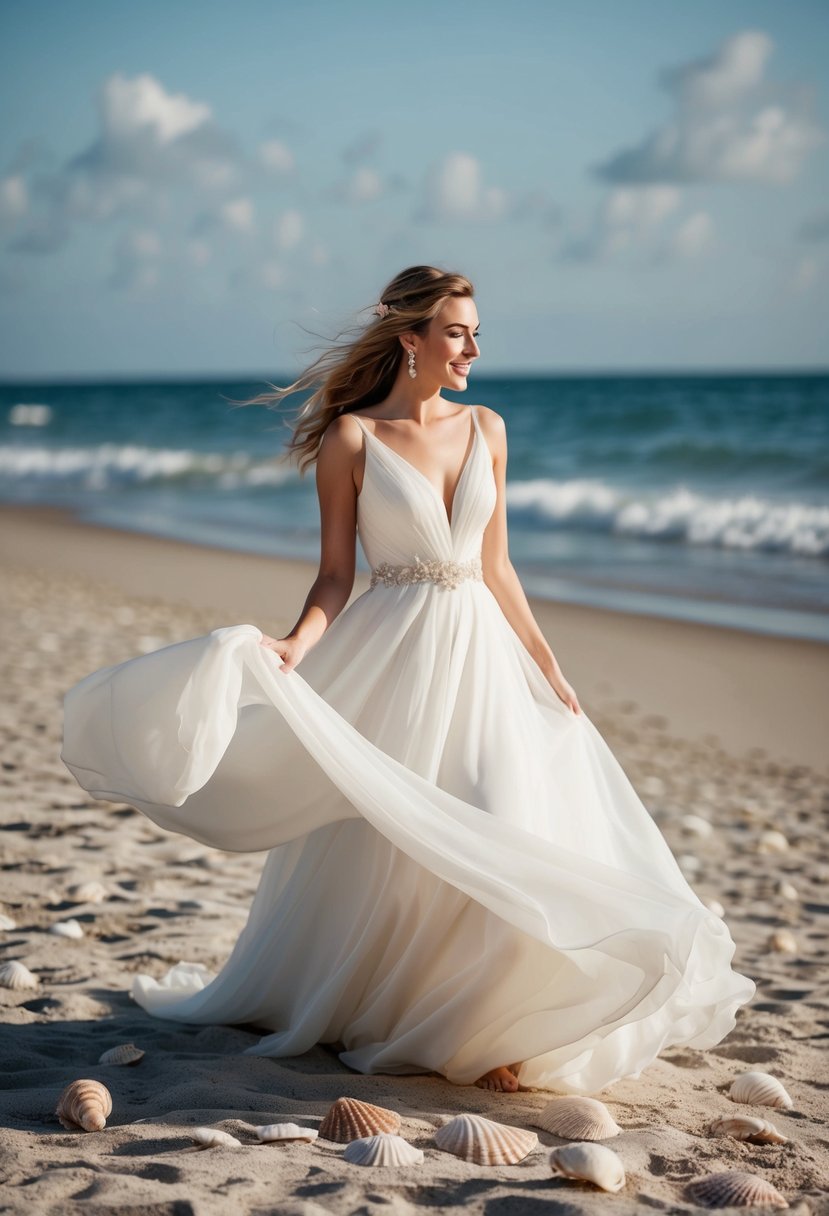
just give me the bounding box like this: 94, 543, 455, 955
233, 266, 474, 474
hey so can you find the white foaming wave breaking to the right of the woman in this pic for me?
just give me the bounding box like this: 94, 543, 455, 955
507, 478, 829, 557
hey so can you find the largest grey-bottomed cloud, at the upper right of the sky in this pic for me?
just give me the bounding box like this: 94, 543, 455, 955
593, 30, 825, 182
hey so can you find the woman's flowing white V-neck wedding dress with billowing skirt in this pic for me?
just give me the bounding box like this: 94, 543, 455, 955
62, 407, 755, 1093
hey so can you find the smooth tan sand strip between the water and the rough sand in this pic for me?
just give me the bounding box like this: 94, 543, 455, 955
0, 505, 829, 775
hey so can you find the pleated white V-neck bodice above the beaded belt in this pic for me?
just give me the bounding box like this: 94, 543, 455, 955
354, 405, 497, 567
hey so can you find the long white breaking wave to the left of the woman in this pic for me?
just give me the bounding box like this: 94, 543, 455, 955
0, 444, 295, 490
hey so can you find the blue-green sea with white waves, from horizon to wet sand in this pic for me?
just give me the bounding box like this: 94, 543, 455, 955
0, 373, 829, 640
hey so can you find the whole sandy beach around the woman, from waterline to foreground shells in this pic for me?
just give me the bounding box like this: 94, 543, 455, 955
0, 508, 829, 1216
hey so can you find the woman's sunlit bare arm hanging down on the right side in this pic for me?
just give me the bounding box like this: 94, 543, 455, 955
478, 405, 581, 714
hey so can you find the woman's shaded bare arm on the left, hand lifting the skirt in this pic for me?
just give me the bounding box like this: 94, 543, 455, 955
263, 417, 362, 671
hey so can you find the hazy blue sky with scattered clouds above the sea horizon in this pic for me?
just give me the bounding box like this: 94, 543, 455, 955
0, 0, 829, 378
